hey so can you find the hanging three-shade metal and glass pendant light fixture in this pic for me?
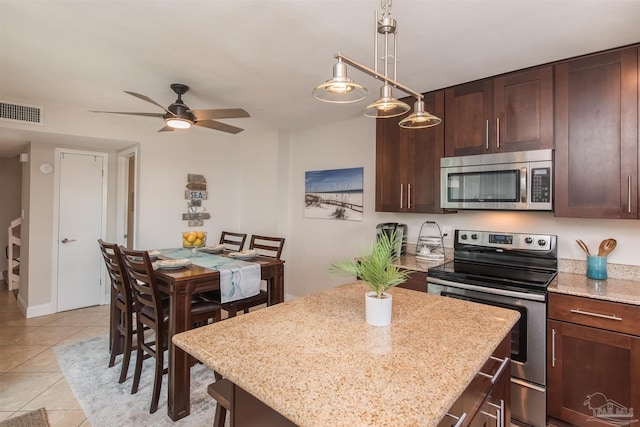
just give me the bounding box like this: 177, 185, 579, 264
312, 0, 441, 129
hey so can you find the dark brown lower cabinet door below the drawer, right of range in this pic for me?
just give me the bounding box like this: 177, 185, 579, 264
547, 320, 640, 426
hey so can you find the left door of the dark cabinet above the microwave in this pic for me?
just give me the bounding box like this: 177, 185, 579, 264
444, 79, 495, 157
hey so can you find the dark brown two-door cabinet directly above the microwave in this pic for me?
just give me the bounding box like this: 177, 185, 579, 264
444, 66, 553, 156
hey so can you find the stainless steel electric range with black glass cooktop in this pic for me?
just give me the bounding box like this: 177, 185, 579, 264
427, 230, 558, 427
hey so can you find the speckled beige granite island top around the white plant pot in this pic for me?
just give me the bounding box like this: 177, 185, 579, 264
173, 282, 519, 426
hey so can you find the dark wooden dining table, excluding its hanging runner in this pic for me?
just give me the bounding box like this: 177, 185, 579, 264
115, 249, 284, 421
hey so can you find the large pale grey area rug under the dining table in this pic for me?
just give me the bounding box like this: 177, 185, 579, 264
53, 335, 215, 427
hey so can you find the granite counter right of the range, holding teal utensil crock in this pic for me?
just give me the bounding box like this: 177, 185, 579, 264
548, 272, 640, 305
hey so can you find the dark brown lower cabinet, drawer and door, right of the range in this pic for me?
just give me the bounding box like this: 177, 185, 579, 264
547, 294, 640, 427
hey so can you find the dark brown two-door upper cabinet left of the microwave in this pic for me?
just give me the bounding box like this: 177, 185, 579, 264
376, 91, 444, 213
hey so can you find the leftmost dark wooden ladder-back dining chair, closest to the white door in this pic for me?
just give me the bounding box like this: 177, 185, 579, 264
98, 239, 136, 383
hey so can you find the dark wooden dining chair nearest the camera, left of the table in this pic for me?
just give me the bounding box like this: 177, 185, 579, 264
120, 247, 221, 414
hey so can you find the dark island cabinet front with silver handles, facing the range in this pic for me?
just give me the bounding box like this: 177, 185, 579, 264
438, 335, 511, 427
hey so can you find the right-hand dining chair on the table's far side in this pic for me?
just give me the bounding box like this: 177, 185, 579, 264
199, 234, 285, 317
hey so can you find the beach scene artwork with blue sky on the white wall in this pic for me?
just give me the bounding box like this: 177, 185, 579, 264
304, 167, 364, 221
